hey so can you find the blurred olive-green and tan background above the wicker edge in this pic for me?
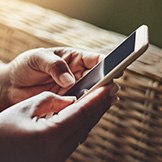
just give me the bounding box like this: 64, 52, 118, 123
19, 0, 162, 48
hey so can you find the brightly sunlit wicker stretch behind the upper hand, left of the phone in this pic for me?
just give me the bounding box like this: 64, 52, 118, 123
0, 1, 123, 61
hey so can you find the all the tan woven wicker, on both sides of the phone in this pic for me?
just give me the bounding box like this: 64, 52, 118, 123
0, 0, 162, 162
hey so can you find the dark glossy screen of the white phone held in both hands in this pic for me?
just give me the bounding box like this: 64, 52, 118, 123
65, 32, 136, 98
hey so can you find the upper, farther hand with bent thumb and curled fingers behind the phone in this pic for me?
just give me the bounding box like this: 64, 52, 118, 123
0, 48, 103, 110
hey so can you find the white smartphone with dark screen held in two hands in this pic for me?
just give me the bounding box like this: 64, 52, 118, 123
65, 25, 149, 99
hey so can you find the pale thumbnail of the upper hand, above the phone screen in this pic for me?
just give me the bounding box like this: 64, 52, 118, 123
60, 72, 75, 87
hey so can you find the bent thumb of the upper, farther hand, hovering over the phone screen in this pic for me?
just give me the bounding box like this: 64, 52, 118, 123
34, 49, 75, 88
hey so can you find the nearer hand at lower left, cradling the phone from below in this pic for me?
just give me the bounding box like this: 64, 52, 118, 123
0, 83, 118, 162
